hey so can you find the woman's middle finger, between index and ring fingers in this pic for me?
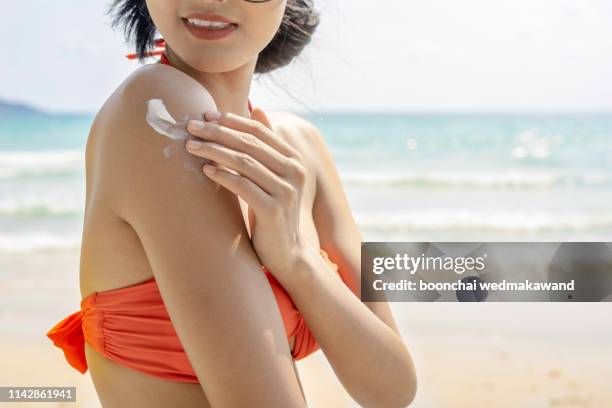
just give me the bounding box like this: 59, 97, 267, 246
187, 120, 297, 178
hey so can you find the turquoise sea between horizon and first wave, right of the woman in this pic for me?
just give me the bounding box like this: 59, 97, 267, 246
311, 114, 612, 186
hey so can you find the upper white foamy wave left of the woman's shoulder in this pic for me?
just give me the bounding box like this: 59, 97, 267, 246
0, 150, 85, 180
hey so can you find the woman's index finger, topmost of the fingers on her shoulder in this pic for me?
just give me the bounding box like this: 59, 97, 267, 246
203, 111, 298, 157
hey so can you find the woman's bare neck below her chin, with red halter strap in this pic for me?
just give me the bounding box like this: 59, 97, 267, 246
166, 47, 257, 118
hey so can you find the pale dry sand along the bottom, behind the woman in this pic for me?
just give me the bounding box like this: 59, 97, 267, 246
0, 322, 612, 408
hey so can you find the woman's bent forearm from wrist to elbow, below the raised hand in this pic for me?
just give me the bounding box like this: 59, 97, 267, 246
281, 244, 415, 407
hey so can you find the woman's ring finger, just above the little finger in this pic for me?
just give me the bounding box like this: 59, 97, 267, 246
188, 142, 292, 197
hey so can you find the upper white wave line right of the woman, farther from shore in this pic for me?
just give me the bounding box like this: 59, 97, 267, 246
341, 170, 612, 188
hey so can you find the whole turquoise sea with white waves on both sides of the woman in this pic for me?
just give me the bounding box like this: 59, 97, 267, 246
0, 113, 612, 252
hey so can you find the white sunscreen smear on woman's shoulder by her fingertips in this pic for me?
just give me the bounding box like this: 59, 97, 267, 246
146, 99, 218, 188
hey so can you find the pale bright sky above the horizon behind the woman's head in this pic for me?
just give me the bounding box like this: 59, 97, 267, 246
0, 0, 612, 112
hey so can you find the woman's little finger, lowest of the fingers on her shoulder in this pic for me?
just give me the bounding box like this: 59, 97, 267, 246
202, 164, 273, 215
